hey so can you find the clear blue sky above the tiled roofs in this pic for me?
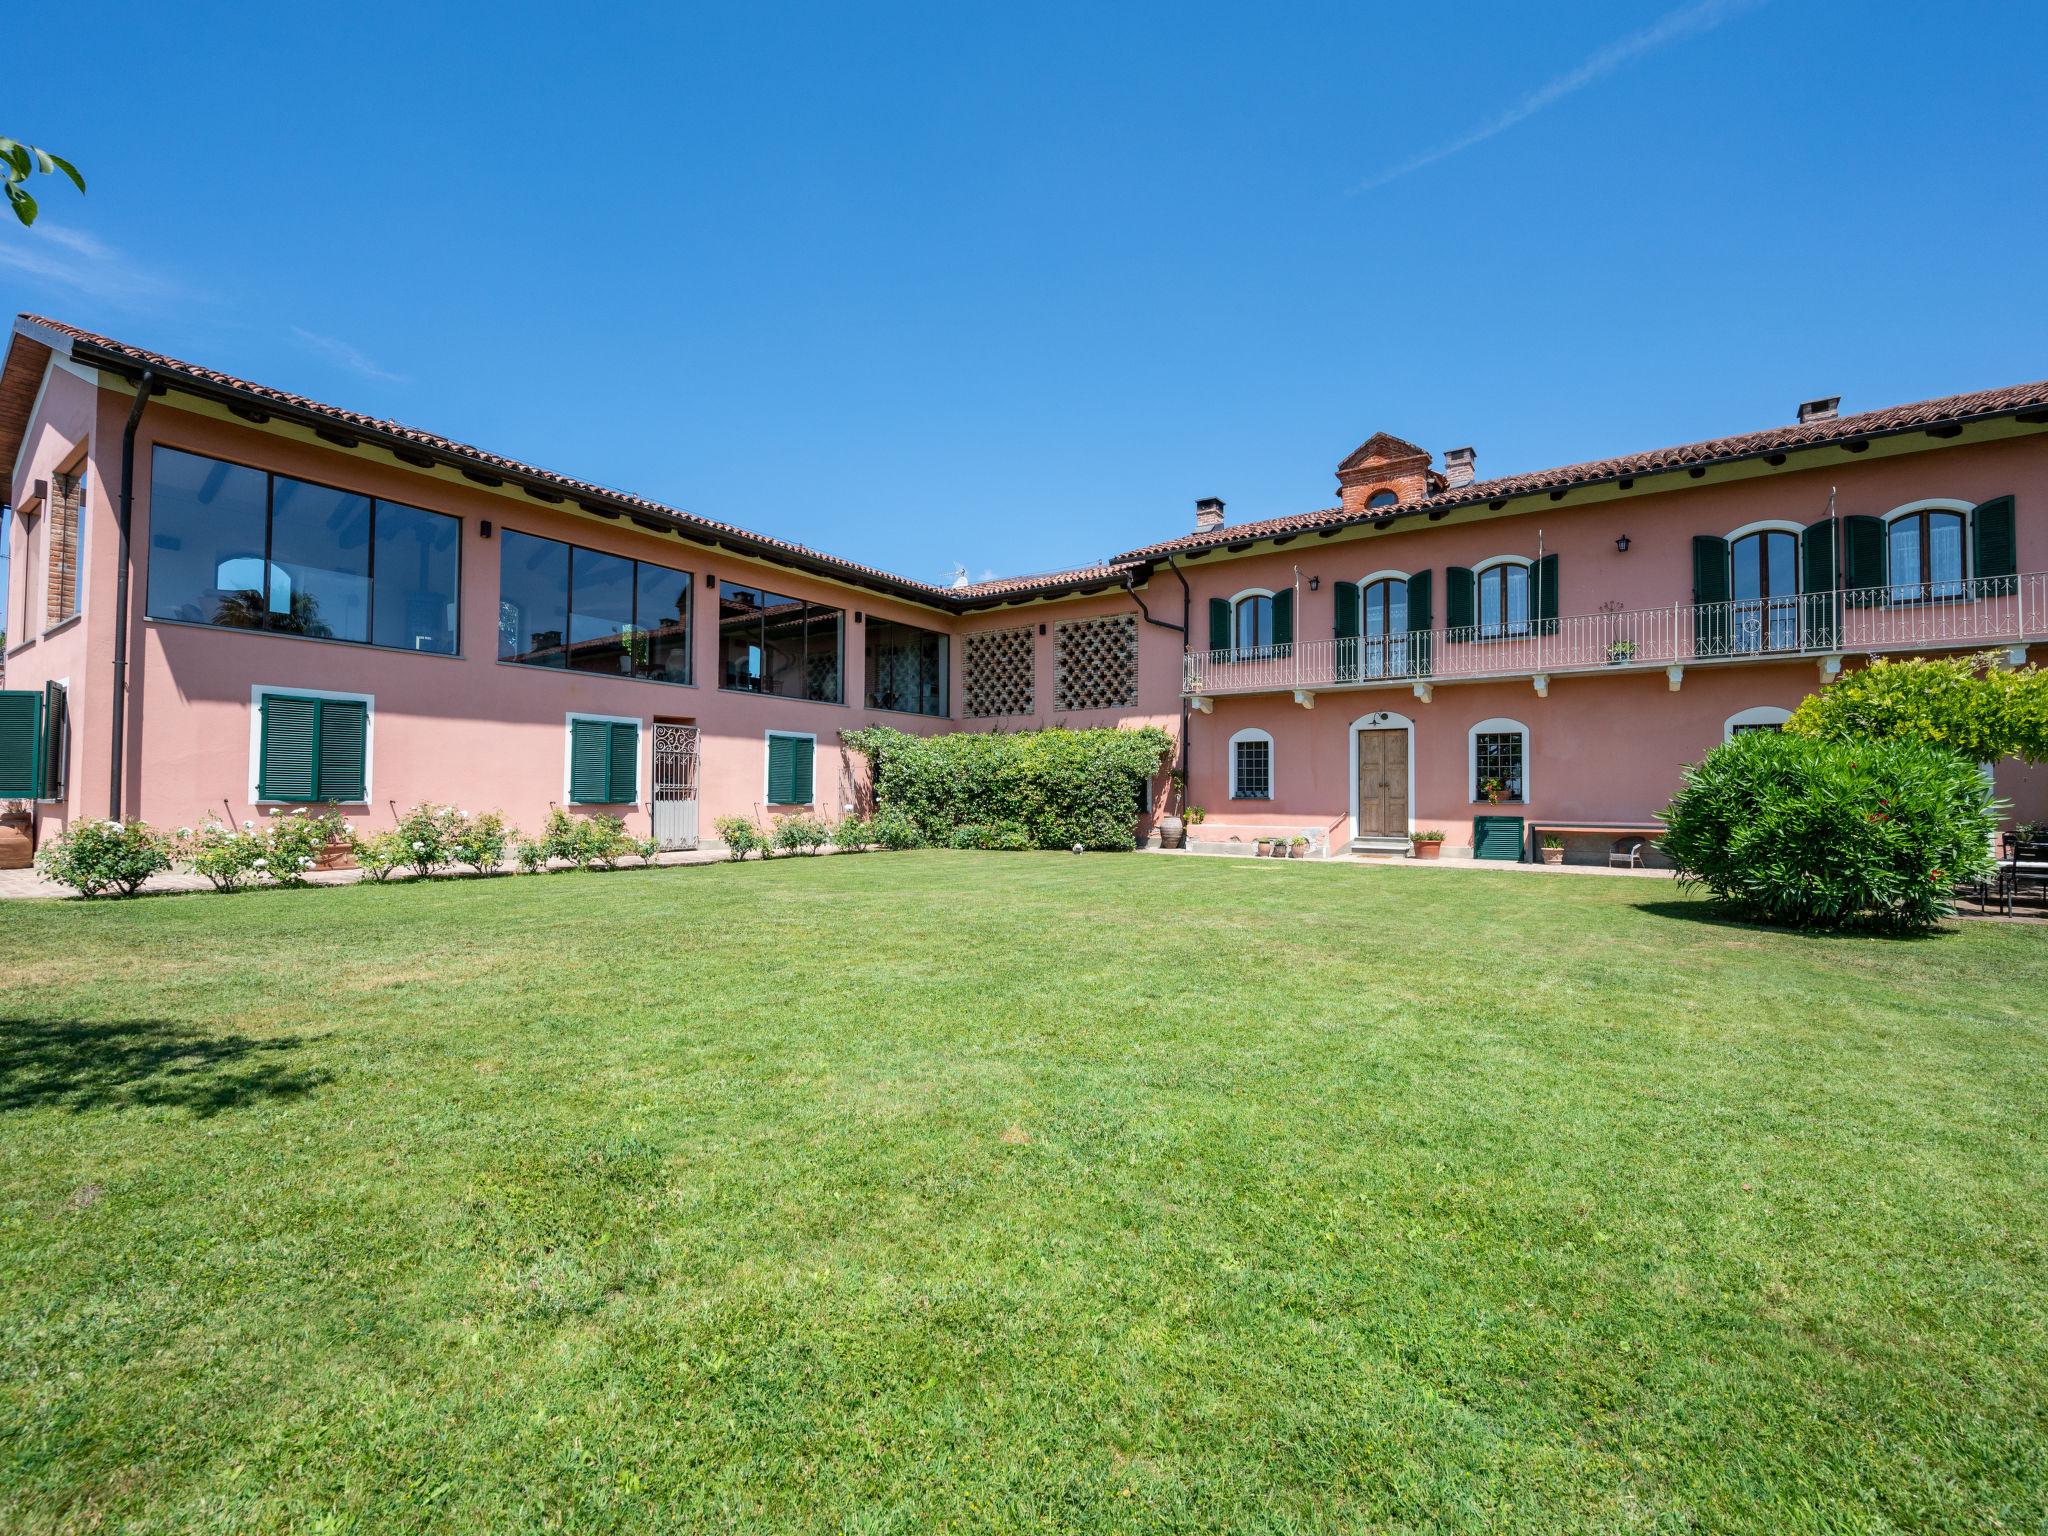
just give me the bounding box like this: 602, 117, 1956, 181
0, 0, 2048, 580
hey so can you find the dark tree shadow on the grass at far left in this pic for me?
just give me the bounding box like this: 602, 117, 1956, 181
0, 1018, 330, 1116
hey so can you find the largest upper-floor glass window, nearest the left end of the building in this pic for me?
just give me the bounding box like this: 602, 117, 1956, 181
147, 446, 461, 655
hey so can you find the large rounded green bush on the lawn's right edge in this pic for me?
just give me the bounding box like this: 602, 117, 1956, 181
1657, 731, 1997, 932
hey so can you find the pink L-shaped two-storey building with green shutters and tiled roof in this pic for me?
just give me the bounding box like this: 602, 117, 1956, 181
0, 315, 2048, 858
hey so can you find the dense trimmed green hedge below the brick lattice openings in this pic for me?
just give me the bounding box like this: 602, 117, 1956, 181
842, 725, 1174, 852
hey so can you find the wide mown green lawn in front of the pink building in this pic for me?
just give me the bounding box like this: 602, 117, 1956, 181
0, 854, 2048, 1532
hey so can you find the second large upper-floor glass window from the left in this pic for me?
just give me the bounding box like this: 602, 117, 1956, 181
498, 530, 690, 682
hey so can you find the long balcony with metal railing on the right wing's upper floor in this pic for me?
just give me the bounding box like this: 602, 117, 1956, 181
1182, 575, 2048, 707
